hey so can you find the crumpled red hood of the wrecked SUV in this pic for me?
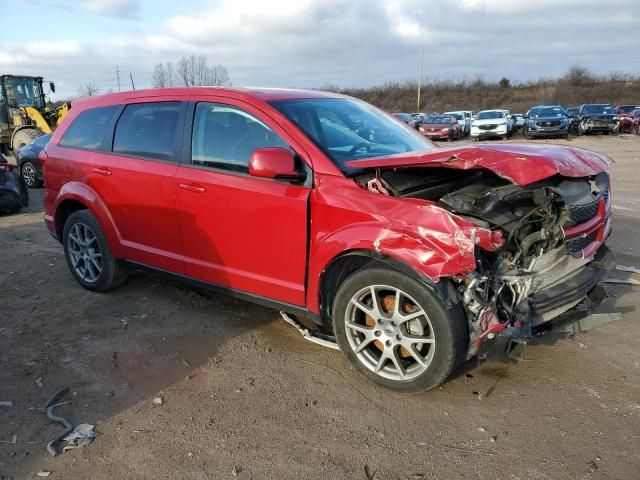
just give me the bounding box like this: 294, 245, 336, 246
347, 143, 613, 185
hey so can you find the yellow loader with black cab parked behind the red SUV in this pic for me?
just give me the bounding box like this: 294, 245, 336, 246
0, 75, 70, 154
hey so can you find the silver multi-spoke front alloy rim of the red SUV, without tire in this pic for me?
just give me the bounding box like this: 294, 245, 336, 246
344, 285, 436, 381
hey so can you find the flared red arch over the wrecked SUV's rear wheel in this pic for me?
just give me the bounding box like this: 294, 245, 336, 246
54, 182, 122, 257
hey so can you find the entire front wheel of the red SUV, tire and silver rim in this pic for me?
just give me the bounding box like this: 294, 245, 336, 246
333, 267, 469, 393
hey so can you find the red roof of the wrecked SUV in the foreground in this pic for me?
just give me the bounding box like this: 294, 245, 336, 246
74, 87, 344, 109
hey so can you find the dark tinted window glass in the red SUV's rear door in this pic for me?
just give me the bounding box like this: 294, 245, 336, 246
113, 102, 183, 161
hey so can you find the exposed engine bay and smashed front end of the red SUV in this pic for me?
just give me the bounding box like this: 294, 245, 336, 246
355, 167, 612, 356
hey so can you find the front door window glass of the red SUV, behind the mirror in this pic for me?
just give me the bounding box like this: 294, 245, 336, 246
191, 103, 289, 173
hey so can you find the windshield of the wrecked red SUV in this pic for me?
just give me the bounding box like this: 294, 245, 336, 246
270, 98, 436, 172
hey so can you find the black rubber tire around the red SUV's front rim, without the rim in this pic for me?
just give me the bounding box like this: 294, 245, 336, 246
333, 267, 469, 393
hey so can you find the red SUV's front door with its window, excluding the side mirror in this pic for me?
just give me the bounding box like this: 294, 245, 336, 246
176, 99, 311, 305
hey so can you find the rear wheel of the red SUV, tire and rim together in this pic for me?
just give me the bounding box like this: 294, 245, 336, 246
62, 210, 127, 292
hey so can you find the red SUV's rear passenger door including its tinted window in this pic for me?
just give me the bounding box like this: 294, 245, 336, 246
88, 98, 187, 273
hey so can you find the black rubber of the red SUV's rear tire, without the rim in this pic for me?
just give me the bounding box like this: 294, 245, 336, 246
62, 210, 128, 292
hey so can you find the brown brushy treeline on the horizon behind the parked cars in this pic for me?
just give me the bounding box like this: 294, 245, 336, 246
330, 66, 640, 113
